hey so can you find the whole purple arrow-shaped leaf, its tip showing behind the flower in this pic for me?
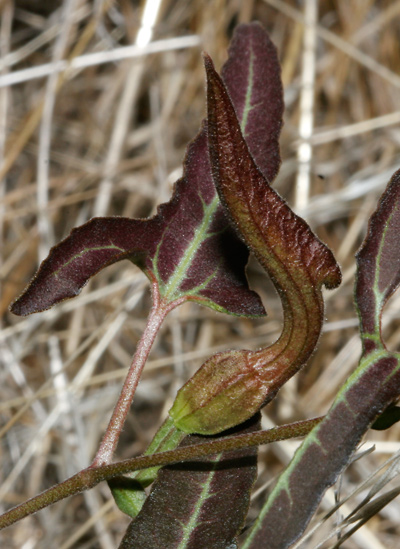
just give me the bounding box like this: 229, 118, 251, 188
11, 24, 283, 322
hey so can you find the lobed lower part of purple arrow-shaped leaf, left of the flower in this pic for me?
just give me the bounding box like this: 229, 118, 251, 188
11, 127, 264, 316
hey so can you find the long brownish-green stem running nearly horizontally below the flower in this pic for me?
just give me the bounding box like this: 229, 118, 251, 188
0, 417, 323, 529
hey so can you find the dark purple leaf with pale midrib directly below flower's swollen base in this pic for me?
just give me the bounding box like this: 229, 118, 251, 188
120, 414, 260, 549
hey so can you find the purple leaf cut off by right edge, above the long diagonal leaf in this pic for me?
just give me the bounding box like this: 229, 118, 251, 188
355, 170, 400, 350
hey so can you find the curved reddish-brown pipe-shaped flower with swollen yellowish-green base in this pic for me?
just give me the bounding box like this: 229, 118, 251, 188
170, 56, 341, 434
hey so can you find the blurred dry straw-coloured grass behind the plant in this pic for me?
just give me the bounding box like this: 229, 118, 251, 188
0, 0, 400, 549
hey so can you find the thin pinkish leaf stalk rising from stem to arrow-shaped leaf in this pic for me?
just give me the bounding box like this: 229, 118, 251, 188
91, 283, 170, 467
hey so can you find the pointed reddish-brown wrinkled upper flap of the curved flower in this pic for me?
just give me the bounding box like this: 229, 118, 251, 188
205, 56, 340, 294
